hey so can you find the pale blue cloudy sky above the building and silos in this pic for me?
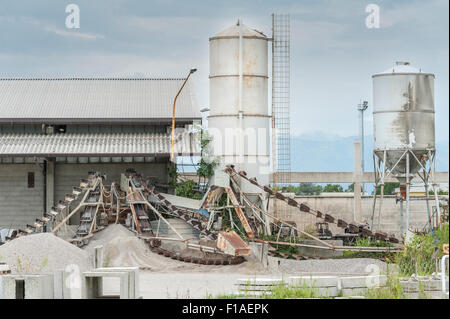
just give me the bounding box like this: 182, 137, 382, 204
0, 0, 449, 144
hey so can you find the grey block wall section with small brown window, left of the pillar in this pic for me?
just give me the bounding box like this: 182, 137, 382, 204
0, 164, 44, 228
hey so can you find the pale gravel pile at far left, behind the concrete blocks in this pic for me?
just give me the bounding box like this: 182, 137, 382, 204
0, 233, 92, 273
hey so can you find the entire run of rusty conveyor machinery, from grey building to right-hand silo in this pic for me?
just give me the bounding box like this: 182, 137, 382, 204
0, 165, 401, 265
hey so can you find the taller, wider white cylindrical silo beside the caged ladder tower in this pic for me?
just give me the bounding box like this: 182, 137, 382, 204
208, 21, 270, 193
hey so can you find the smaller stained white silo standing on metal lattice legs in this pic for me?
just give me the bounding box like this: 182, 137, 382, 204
372, 62, 439, 235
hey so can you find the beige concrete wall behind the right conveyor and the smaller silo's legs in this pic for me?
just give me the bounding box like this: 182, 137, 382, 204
270, 196, 434, 237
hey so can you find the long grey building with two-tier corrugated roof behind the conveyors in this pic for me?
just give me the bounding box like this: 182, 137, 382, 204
0, 78, 201, 228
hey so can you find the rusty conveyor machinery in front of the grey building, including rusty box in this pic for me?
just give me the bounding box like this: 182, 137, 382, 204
0, 169, 246, 265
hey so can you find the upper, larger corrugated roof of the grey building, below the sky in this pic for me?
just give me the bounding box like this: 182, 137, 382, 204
0, 78, 201, 122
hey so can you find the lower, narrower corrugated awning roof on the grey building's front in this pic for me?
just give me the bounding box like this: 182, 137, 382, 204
0, 133, 200, 157
